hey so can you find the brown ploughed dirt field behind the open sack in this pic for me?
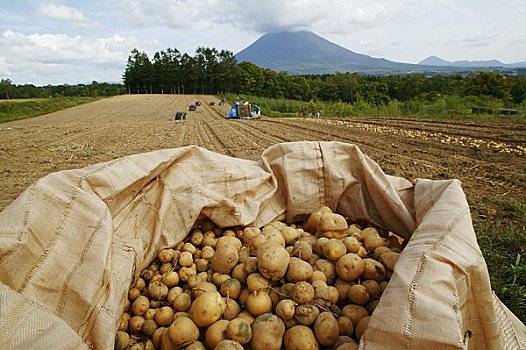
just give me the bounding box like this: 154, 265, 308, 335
0, 95, 526, 230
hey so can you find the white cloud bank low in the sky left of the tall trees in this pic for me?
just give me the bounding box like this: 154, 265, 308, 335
0, 31, 132, 84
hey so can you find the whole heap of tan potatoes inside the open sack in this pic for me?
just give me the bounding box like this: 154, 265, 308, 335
115, 206, 402, 350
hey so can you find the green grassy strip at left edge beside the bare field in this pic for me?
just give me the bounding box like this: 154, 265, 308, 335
0, 97, 100, 123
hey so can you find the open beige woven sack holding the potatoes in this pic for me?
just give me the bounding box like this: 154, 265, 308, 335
0, 142, 526, 350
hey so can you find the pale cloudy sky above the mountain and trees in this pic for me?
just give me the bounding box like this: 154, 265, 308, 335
0, 0, 526, 85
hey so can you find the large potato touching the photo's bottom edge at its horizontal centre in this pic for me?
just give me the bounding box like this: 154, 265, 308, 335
250, 313, 285, 350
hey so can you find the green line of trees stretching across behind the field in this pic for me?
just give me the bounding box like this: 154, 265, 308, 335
0, 47, 526, 108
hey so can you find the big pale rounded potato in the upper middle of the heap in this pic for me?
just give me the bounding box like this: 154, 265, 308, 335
258, 241, 290, 281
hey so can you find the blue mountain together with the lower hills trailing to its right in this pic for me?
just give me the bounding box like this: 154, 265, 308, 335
236, 31, 526, 74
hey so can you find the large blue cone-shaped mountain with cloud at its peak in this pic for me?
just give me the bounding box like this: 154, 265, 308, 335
236, 31, 418, 74
